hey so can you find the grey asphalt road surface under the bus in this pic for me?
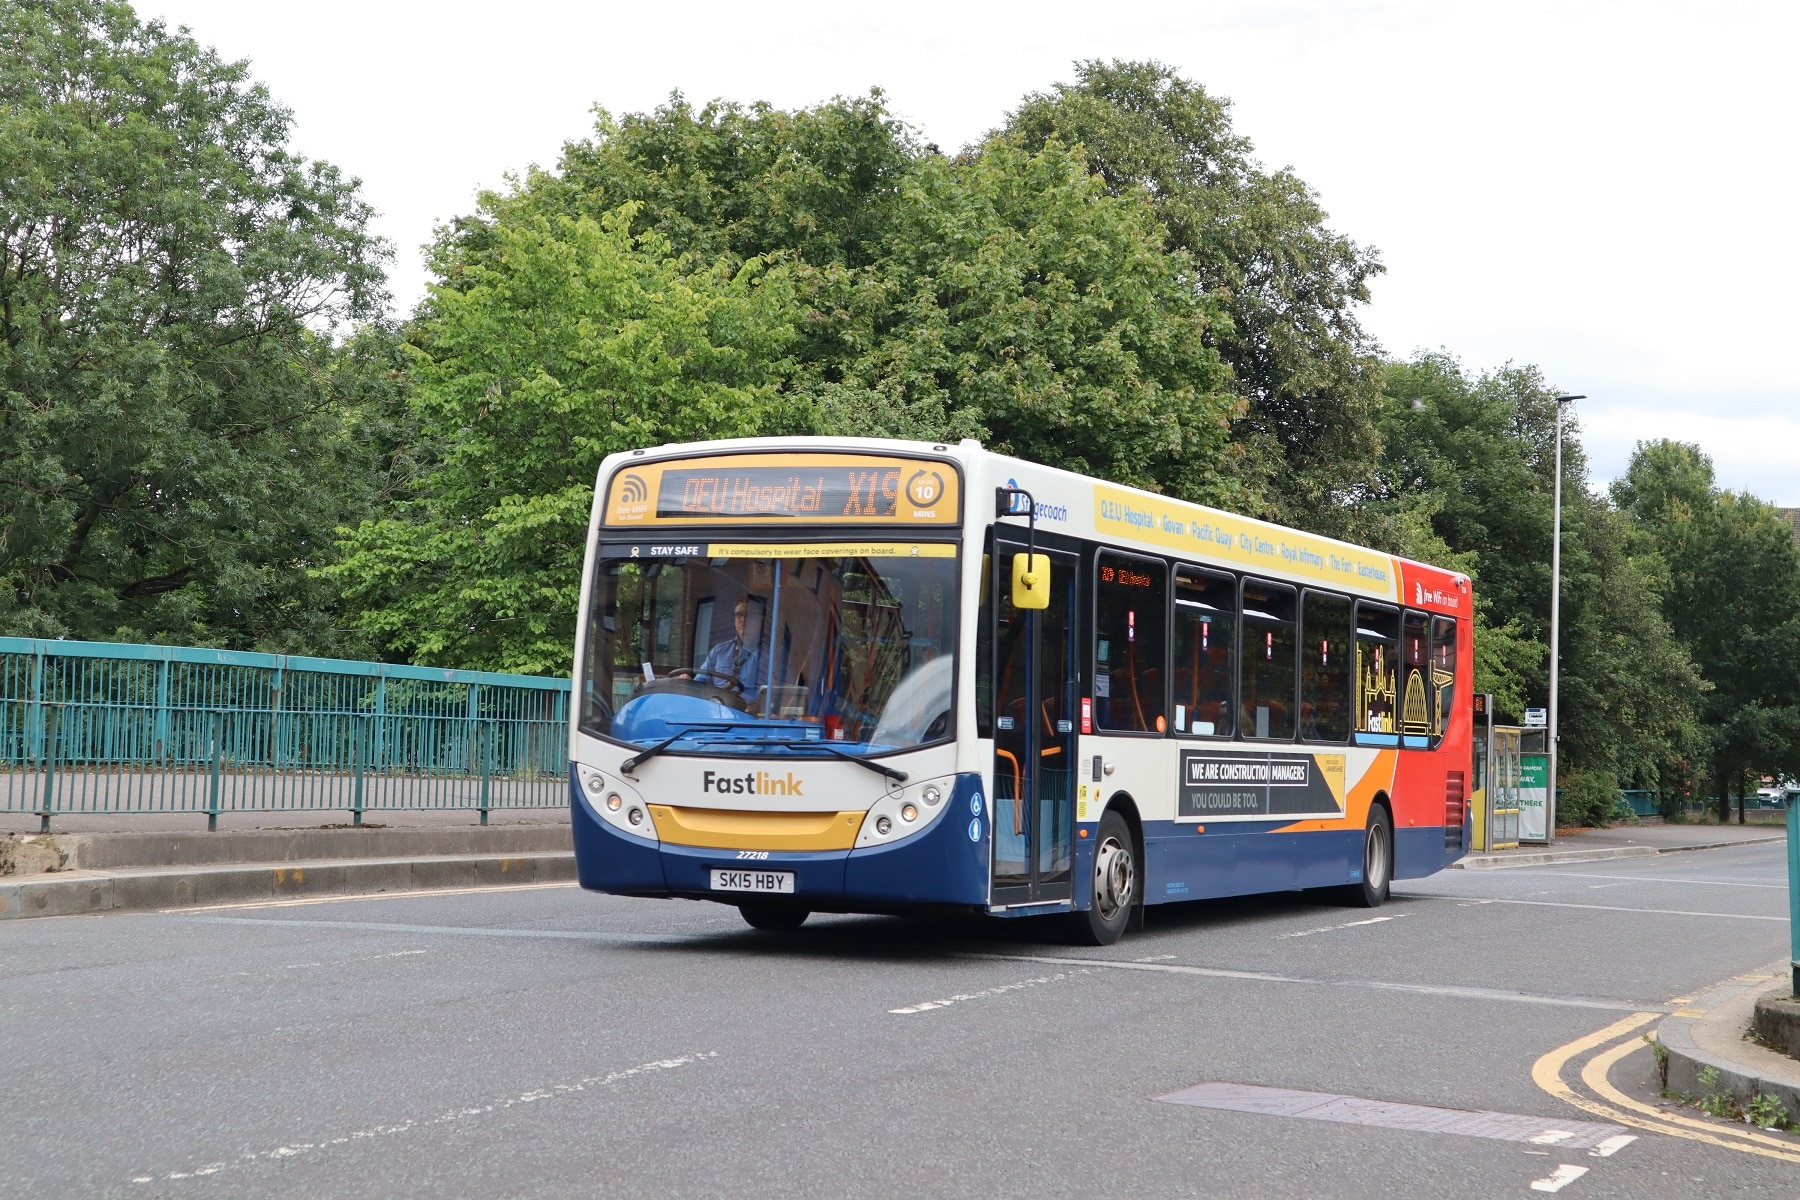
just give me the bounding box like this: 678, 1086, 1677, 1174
0, 846, 1800, 1200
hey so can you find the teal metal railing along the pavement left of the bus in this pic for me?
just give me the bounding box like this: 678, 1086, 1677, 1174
0, 637, 569, 831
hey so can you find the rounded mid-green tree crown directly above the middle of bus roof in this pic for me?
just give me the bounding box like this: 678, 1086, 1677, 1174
797, 139, 1237, 500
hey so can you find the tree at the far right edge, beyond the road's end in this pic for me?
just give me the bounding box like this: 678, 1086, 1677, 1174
1613, 441, 1800, 820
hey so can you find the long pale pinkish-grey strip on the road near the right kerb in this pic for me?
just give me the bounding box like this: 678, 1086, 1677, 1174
1156, 1081, 1625, 1150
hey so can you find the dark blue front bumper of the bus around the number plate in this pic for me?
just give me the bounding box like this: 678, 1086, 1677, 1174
569, 774, 988, 912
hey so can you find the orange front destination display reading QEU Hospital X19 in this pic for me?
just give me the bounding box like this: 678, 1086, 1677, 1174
607, 453, 959, 525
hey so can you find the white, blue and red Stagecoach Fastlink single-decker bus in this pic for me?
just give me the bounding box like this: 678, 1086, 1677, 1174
569, 439, 1472, 945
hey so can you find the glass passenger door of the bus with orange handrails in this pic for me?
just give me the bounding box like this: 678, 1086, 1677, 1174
990, 538, 1080, 905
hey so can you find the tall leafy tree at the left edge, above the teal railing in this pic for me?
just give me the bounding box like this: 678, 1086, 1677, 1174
0, 0, 389, 651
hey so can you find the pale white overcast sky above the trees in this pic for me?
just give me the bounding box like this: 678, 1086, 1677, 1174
139, 0, 1800, 506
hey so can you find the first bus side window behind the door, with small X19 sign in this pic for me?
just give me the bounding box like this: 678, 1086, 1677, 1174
1094, 551, 1168, 734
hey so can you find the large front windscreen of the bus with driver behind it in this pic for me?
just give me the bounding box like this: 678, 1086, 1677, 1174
581, 543, 958, 748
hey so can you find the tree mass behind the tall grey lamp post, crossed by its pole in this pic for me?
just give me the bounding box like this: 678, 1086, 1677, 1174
1359, 353, 1705, 820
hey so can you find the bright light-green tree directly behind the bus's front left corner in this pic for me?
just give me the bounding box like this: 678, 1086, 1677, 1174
320, 206, 806, 673
